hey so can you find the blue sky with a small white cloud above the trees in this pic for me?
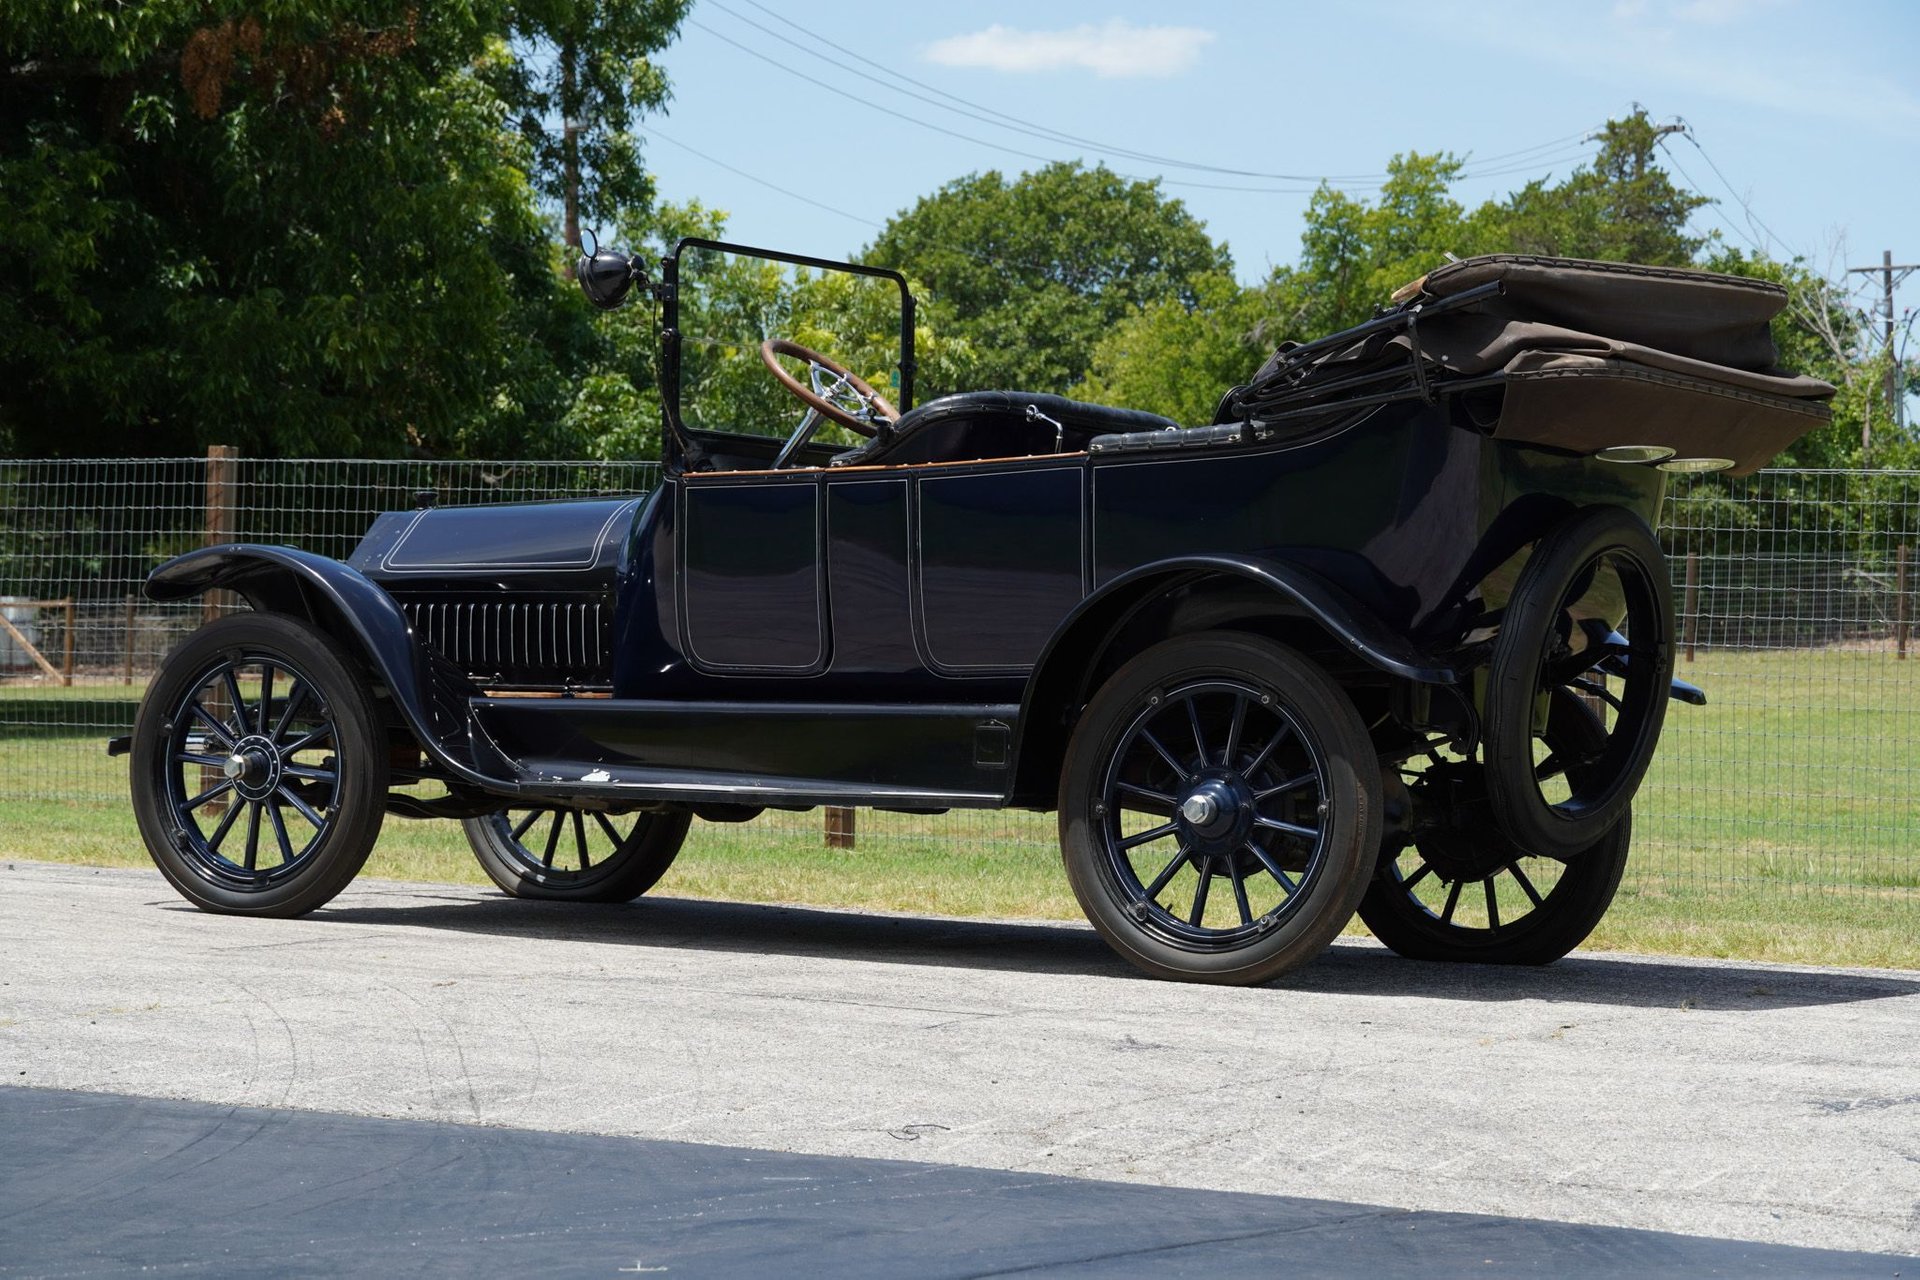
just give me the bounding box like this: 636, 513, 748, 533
645, 0, 1920, 320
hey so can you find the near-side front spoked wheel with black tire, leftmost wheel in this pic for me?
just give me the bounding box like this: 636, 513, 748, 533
131, 614, 388, 915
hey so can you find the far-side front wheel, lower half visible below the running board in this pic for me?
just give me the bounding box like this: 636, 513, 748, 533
461, 806, 693, 902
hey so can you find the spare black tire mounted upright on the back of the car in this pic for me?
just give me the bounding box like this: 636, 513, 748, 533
1484, 507, 1674, 858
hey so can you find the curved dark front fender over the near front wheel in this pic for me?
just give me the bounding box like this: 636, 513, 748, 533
146, 543, 505, 789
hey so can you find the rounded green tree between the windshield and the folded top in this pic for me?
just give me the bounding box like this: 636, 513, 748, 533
862, 163, 1233, 395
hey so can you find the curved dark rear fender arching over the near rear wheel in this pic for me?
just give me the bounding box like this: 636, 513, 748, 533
1014, 557, 1459, 808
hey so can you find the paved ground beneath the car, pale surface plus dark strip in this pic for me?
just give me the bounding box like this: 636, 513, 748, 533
0, 862, 1920, 1274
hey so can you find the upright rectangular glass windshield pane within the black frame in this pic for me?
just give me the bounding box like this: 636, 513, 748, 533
680, 244, 906, 447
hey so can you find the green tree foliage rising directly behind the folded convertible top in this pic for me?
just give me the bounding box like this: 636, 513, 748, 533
1083, 109, 1920, 466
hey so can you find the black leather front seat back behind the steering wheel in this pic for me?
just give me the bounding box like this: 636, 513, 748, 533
833, 391, 1179, 466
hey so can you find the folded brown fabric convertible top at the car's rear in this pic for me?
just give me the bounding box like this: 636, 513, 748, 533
1219, 253, 1834, 472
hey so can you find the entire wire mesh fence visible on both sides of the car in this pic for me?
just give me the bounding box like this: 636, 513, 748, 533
0, 453, 1920, 910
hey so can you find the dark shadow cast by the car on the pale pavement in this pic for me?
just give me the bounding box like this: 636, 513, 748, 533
309, 896, 1920, 1011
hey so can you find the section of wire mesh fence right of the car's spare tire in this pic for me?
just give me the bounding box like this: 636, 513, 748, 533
1632, 470, 1920, 908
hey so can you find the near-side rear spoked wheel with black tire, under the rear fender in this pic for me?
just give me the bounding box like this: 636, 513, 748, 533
1060, 631, 1380, 984
